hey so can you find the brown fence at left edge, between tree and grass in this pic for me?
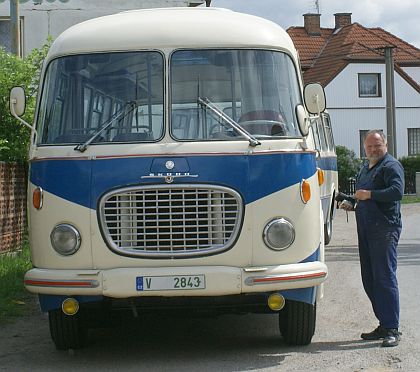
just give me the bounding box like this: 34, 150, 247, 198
0, 162, 27, 253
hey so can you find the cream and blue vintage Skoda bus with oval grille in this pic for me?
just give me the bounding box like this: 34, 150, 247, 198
10, 8, 336, 349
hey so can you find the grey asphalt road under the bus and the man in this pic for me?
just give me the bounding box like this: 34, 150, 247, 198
0, 204, 420, 372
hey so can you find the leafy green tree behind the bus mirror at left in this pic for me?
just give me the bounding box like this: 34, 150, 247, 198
0, 39, 51, 162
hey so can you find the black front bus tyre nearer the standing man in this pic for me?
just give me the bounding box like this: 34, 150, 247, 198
279, 301, 316, 345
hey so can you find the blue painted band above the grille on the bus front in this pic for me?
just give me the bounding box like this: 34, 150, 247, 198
30, 152, 316, 209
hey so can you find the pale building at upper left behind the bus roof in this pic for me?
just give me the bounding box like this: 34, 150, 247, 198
0, 0, 206, 56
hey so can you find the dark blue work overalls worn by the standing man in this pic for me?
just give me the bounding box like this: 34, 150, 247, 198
356, 155, 404, 329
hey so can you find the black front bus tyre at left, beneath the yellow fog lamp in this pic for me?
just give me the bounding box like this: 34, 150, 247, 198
48, 309, 87, 350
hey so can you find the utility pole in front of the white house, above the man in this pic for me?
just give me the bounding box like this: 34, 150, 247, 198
384, 46, 397, 157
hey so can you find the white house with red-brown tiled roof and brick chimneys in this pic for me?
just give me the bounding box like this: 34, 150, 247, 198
287, 13, 420, 157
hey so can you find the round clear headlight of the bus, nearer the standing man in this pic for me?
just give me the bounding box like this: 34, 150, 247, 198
263, 218, 295, 251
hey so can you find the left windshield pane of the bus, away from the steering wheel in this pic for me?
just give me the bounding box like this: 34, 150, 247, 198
38, 52, 164, 144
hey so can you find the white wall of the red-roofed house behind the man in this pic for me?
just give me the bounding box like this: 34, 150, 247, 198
325, 63, 420, 157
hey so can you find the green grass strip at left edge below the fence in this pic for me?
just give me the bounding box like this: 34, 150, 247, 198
0, 241, 32, 324
